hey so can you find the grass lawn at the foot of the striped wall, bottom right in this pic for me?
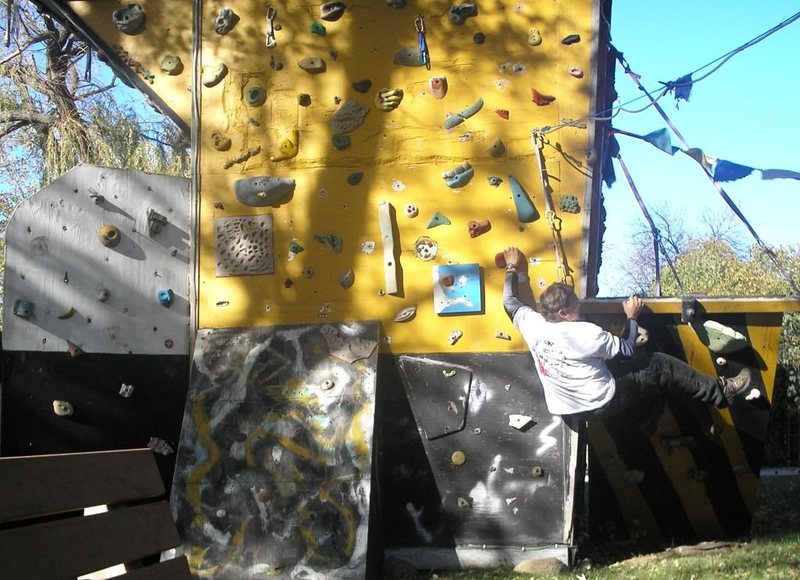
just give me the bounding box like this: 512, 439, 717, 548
417, 476, 800, 580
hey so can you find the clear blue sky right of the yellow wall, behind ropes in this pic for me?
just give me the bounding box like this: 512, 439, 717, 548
599, 0, 800, 296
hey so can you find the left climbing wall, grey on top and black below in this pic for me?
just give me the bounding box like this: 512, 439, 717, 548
0, 165, 192, 483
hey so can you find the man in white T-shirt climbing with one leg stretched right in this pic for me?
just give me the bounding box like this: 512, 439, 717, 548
503, 247, 752, 421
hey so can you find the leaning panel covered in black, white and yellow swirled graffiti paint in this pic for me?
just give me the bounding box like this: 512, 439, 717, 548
171, 322, 378, 578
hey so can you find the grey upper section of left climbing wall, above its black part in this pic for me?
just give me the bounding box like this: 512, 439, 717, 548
3, 165, 192, 355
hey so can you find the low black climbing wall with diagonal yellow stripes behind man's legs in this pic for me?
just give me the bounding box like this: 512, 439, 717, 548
583, 298, 798, 546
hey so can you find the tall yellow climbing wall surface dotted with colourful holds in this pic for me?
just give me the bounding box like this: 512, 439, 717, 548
65, 0, 599, 353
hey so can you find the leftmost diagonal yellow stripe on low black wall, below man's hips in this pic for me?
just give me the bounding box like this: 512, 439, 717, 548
589, 421, 663, 543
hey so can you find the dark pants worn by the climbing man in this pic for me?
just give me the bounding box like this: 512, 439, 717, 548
564, 352, 727, 421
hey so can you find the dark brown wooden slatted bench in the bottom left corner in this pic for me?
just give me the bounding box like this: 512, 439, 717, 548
0, 449, 192, 580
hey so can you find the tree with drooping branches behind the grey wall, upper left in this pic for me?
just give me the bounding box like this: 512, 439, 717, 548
0, 0, 189, 326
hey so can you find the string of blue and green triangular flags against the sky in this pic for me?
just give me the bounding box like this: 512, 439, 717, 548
604, 128, 800, 186
